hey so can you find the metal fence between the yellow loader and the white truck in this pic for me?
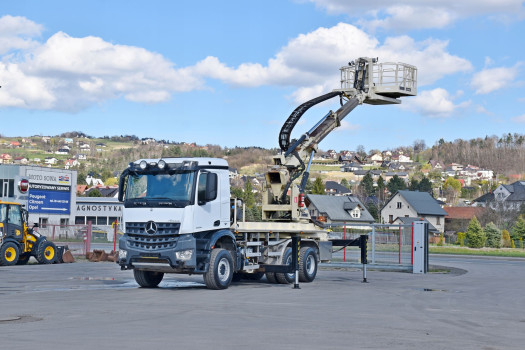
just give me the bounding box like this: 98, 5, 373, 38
35, 222, 122, 256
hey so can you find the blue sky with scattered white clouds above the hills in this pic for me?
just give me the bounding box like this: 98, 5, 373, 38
0, 0, 525, 151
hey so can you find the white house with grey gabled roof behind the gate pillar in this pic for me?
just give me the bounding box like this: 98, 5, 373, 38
381, 190, 447, 232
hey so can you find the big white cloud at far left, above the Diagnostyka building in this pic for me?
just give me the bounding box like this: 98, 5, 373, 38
0, 28, 204, 112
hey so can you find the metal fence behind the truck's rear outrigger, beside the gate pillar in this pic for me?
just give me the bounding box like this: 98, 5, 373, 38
329, 223, 414, 267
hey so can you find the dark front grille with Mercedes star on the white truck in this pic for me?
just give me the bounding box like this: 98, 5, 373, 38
126, 222, 180, 251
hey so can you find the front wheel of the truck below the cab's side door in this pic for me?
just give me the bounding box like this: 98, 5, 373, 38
204, 248, 233, 289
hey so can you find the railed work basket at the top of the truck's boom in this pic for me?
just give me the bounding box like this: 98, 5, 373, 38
334, 57, 417, 105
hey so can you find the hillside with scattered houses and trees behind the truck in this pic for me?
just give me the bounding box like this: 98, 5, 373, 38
0, 133, 525, 247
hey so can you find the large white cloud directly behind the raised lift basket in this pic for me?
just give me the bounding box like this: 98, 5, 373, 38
193, 23, 472, 92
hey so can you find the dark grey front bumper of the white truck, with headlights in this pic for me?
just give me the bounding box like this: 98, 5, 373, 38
118, 235, 204, 273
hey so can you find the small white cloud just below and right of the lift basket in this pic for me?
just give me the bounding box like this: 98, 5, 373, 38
400, 88, 470, 118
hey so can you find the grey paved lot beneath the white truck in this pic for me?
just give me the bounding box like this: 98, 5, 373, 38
0, 259, 525, 350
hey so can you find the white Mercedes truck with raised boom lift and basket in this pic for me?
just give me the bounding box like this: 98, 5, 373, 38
118, 58, 417, 289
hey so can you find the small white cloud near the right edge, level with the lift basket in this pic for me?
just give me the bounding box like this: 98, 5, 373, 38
470, 64, 519, 94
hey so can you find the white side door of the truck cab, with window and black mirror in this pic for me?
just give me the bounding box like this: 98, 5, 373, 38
193, 171, 221, 231
